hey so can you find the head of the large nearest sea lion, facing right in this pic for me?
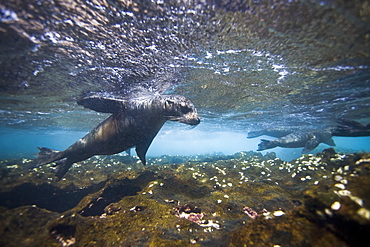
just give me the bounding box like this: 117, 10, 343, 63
161, 95, 200, 125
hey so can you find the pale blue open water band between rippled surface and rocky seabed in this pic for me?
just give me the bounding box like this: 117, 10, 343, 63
0, 125, 370, 161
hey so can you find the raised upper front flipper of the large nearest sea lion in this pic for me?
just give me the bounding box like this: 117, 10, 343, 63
77, 94, 127, 113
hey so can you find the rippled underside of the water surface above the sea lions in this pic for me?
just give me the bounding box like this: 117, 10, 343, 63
0, 1, 370, 130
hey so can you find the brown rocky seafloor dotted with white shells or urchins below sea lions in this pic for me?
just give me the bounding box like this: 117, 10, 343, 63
0, 149, 370, 246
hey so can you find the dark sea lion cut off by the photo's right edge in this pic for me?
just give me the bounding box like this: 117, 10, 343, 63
332, 118, 370, 137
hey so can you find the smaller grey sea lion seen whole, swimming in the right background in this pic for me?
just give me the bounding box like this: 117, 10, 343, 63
257, 130, 335, 153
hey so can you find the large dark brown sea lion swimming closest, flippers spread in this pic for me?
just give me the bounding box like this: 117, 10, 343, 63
34, 95, 200, 181
